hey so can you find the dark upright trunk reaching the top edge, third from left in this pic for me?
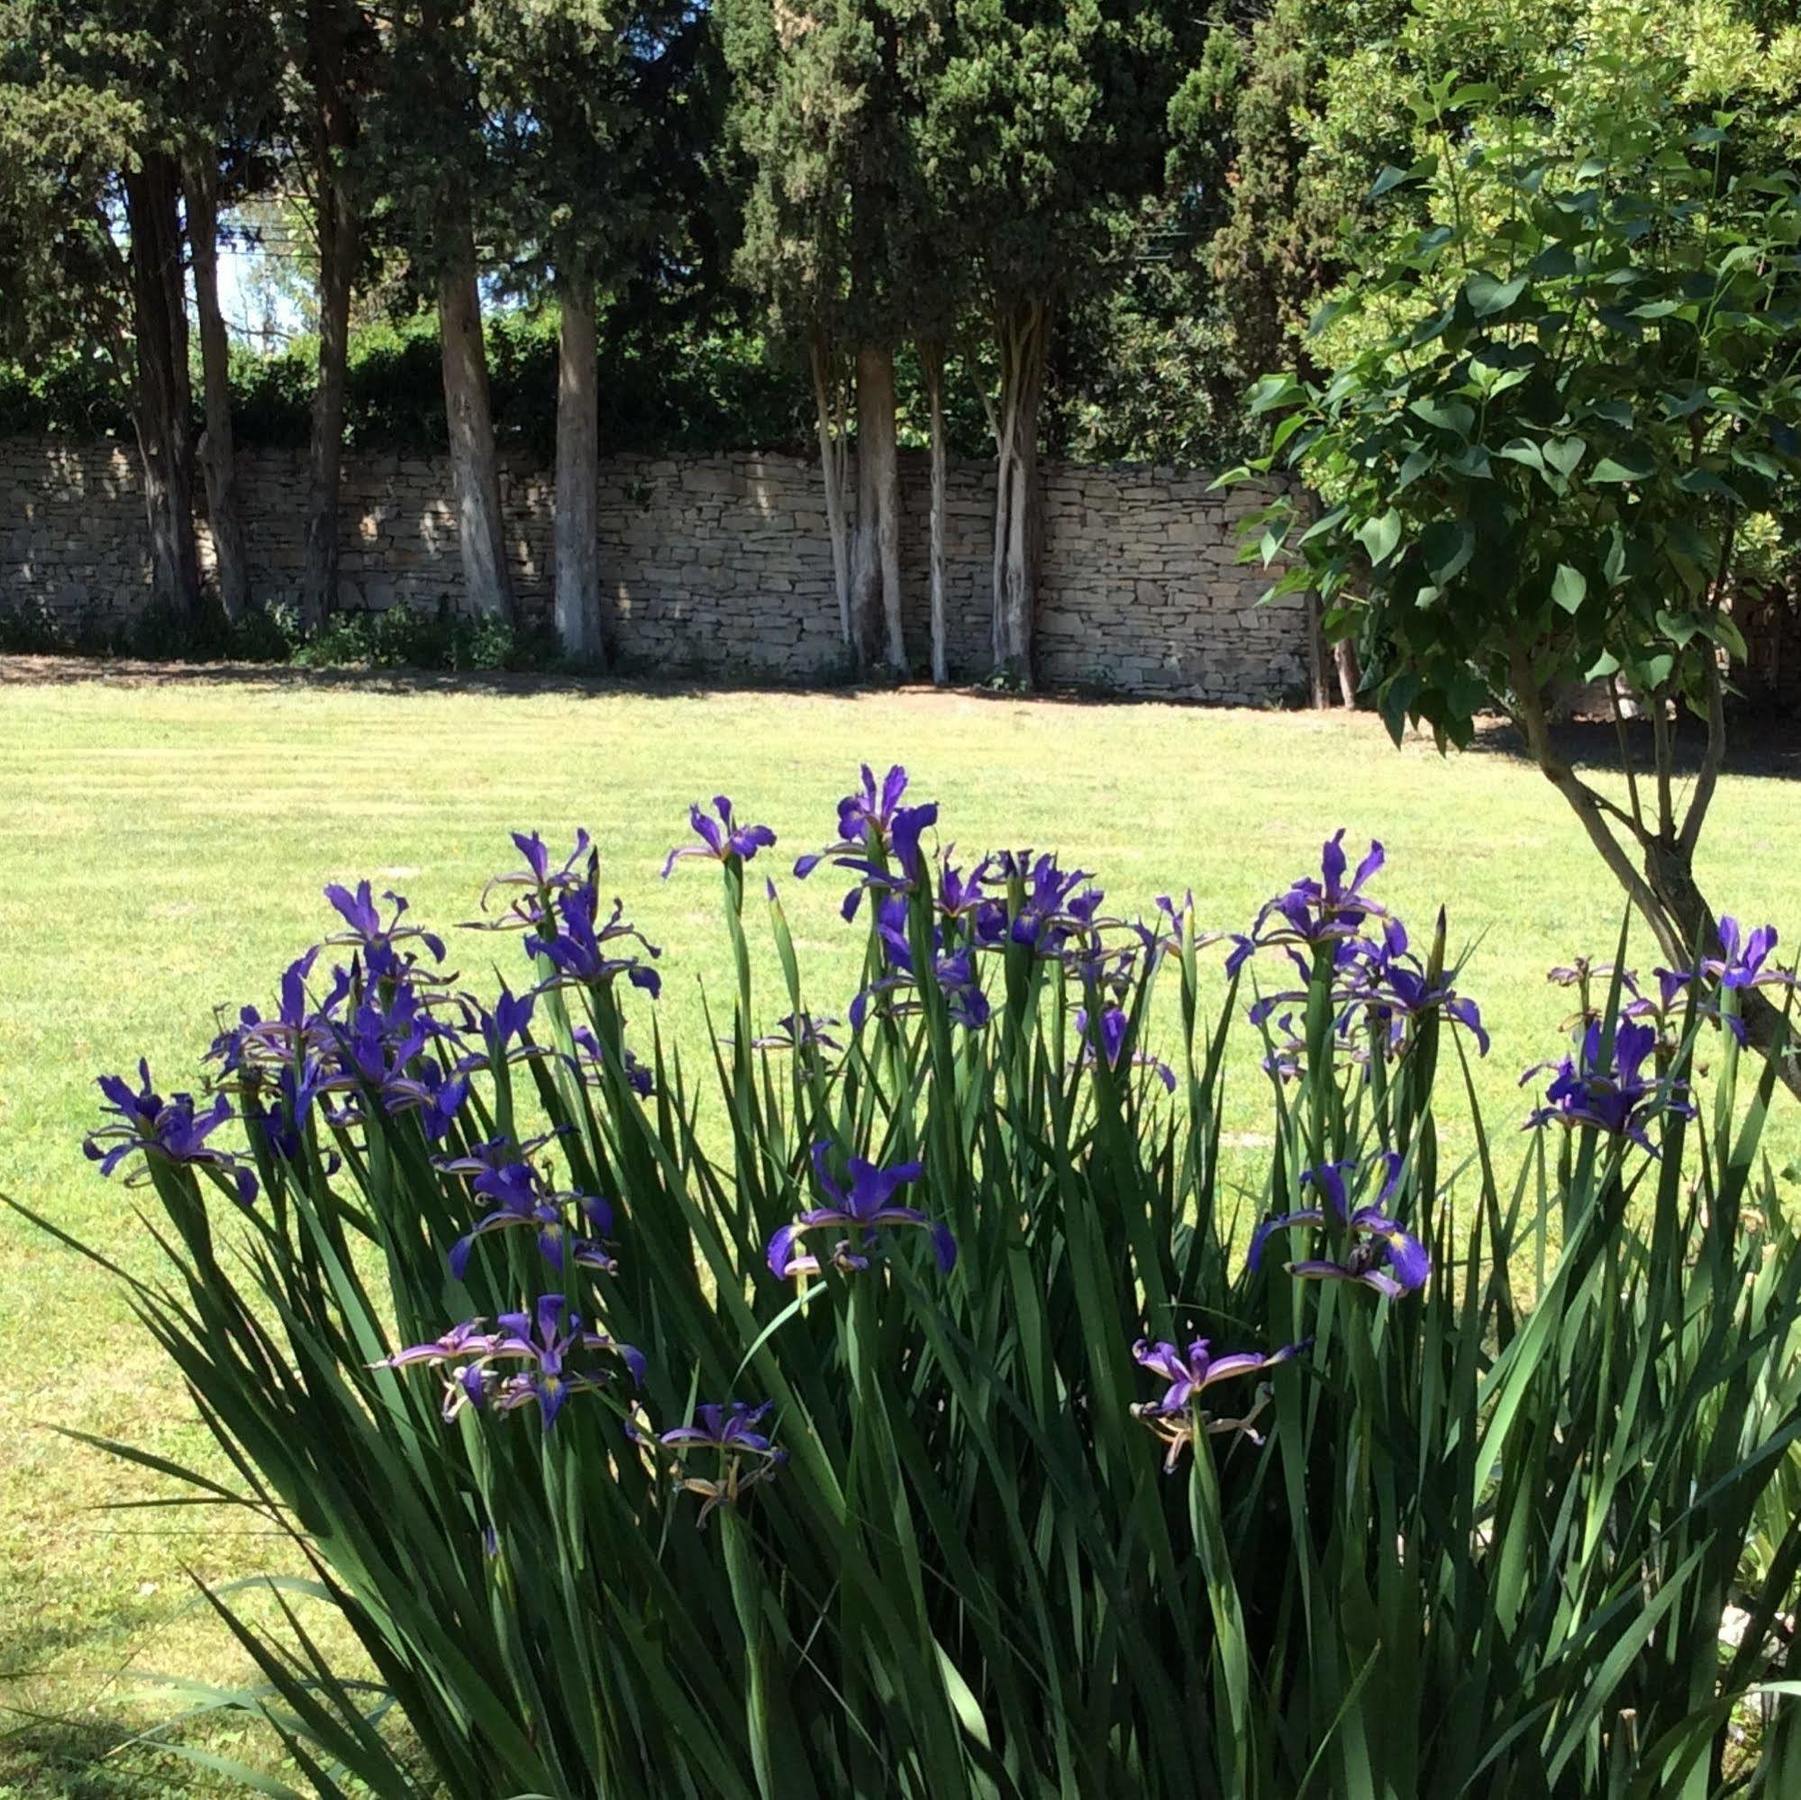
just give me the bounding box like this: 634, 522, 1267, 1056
301, 0, 358, 631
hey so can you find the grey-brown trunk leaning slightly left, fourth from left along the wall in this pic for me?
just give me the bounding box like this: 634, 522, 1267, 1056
438, 205, 513, 618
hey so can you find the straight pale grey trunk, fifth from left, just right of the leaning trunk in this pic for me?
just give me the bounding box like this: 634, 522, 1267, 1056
551, 266, 605, 667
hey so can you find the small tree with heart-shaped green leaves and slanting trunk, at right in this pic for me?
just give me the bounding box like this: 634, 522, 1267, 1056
1253, 28, 1801, 1090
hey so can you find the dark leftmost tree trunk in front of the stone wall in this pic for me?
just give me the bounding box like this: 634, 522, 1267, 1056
124, 151, 200, 634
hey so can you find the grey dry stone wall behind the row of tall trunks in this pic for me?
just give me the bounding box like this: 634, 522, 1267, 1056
0, 438, 1306, 705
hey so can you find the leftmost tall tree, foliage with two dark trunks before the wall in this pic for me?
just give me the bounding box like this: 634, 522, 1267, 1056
0, 0, 268, 618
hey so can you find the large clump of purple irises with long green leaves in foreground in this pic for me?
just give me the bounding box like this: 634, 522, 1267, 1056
24, 769, 1801, 1800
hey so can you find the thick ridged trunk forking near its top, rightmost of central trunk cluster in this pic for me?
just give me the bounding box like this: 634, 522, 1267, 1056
992, 299, 1050, 685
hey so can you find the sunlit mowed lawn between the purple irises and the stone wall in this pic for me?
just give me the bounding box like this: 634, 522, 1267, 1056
0, 663, 1801, 1795
